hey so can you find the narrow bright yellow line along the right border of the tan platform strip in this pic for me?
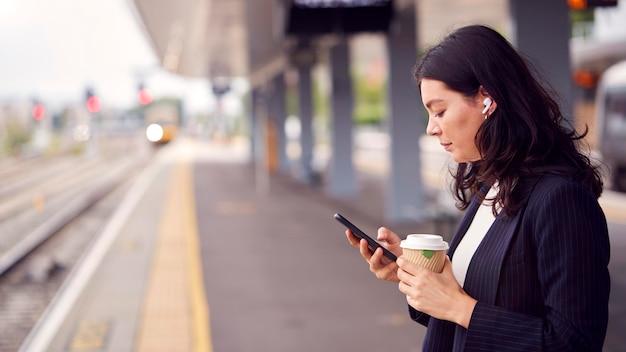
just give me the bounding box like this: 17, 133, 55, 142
182, 161, 213, 352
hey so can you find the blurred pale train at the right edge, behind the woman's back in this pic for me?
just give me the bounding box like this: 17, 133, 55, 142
596, 61, 626, 192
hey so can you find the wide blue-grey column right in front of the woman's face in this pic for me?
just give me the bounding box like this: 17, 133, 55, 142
386, 5, 426, 222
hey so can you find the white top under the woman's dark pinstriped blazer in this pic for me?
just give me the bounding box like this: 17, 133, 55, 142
452, 184, 500, 287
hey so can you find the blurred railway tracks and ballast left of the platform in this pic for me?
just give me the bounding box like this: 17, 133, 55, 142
0, 145, 150, 352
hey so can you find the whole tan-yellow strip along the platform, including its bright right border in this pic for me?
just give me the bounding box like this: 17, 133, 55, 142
136, 151, 213, 352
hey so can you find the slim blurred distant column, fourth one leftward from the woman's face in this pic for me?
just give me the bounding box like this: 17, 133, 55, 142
269, 73, 289, 171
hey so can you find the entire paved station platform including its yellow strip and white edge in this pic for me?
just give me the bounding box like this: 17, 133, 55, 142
17, 139, 626, 352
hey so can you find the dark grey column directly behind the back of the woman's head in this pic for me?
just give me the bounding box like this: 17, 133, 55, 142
509, 0, 574, 118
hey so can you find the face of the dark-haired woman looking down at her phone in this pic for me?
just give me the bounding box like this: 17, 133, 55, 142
420, 79, 488, 163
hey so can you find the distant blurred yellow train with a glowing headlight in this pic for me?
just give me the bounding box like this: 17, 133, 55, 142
143, 99, 181, 144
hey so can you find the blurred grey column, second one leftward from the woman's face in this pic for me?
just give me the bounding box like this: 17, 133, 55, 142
328, 38, 356, 197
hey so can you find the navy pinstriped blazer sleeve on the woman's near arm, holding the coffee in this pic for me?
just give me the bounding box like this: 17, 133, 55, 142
465, 182, 610, 351
